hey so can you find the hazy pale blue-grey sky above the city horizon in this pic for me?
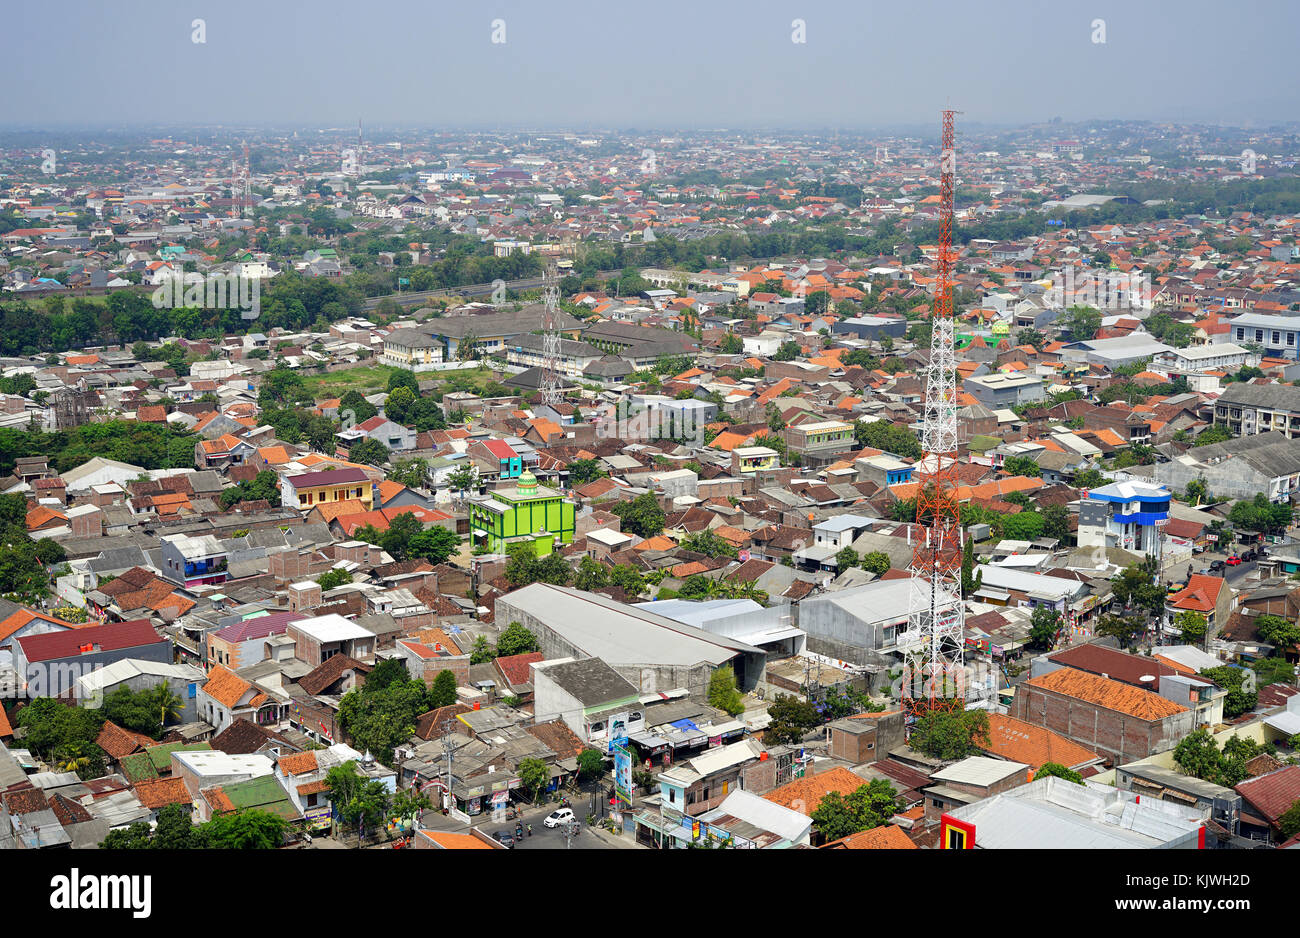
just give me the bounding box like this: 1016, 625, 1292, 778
0, 0, 1300, 129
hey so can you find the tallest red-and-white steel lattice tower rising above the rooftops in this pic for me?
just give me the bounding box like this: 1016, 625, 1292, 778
898, 109, 966, 716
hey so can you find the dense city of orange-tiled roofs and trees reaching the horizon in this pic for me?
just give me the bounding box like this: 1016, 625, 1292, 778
0, 9, 1300, 899
